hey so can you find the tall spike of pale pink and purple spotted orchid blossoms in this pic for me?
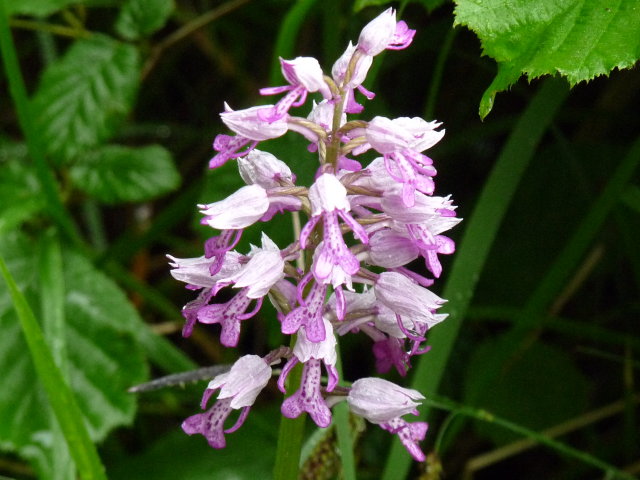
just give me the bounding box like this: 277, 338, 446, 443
170, 9, 459, 461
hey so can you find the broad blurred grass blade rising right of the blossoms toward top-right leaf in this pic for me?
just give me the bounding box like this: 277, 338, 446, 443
383, 79, 568, 480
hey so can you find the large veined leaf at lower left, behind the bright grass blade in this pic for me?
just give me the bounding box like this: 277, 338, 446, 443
0, 233, 146, 451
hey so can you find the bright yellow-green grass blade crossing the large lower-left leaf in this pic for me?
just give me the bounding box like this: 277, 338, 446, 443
0, 257, 107, 480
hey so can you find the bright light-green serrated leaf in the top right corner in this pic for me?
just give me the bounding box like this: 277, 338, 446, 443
455, 0, 640, 117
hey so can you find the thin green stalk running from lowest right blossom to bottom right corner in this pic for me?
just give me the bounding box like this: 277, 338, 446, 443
425, 397, 635, 480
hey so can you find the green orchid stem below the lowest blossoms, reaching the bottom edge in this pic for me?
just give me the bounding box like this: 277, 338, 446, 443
273, 356, 307, 480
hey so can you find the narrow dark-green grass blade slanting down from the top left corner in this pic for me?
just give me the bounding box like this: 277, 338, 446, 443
0, 0, 84, 250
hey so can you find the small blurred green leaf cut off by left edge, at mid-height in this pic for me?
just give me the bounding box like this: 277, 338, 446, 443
0, 138, 45, 234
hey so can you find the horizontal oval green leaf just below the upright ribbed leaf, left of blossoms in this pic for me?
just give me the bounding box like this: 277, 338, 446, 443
71, 145, 180, 203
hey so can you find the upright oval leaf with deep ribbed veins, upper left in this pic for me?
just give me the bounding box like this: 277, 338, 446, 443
32, 35, 140, 162
